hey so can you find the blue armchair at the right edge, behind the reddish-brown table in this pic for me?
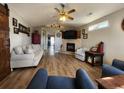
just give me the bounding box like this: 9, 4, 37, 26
102, 59, 124, 77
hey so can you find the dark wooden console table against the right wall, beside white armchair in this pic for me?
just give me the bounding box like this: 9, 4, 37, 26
85, 51, 104, 66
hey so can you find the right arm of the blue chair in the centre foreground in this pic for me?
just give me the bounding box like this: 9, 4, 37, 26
75, 69, 97, 89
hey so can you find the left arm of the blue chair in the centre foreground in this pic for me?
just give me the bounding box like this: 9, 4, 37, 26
27, 69, 48, 89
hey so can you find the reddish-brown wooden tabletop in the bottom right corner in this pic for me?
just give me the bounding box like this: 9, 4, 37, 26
96, 75, 124, 89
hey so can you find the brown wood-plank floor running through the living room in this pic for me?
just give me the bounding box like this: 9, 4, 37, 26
0, 50, 101, 89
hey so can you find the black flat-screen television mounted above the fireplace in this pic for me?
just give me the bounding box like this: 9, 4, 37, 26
63, 30, 77, 39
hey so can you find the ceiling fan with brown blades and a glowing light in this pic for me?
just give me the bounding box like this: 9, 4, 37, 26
54, 4, 76, 21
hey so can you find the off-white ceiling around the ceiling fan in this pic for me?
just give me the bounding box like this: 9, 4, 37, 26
8, 3, 124, 27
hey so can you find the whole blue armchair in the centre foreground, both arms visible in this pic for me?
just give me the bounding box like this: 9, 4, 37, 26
27, 69, 97, 89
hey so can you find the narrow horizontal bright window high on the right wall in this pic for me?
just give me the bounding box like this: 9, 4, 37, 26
88, 20, 109, 31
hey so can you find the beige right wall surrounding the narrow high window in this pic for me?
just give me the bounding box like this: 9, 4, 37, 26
81, 9, 124, 64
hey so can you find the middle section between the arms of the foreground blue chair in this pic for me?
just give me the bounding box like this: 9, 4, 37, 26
47, 76, 75, 89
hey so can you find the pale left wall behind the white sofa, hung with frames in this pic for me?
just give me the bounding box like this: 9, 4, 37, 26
9, 6, 31, 51
